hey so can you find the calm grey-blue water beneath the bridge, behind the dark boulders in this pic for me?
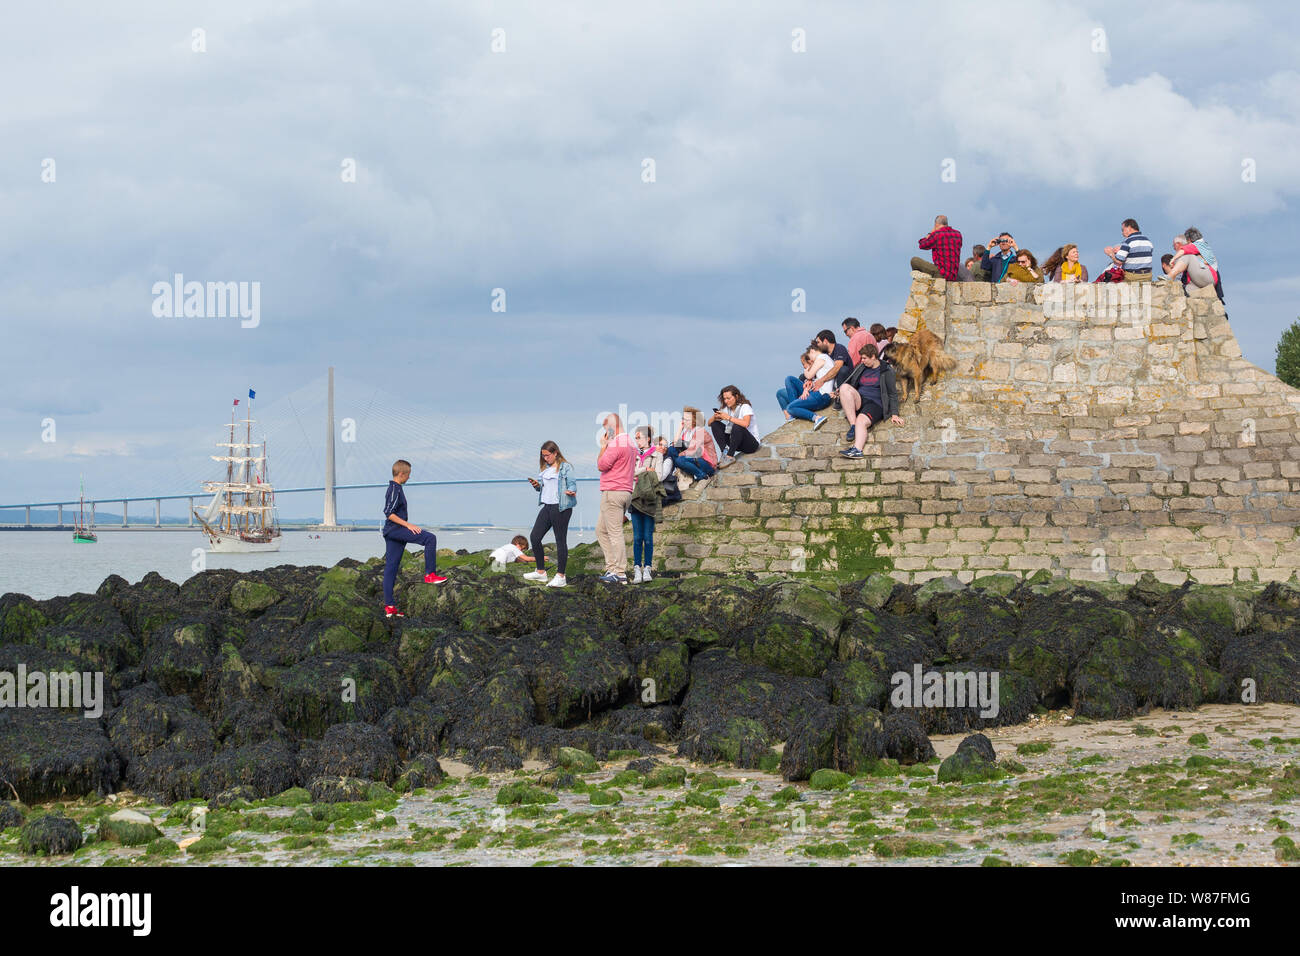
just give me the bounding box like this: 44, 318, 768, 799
0, 528, 561, 598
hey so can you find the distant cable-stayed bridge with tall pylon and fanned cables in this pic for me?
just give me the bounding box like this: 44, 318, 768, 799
0, 368, 598, 531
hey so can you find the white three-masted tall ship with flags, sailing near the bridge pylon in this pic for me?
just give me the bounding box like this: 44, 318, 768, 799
194, 389, 281, 554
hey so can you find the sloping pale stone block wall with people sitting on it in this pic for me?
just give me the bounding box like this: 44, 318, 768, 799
655, 273, 1300, 584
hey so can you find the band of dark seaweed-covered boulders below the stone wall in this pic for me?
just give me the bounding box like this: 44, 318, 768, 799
0, 553, 1300, 839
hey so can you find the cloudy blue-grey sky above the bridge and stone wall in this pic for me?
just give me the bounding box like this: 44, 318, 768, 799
0, 0, 1300, 523
